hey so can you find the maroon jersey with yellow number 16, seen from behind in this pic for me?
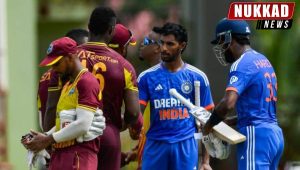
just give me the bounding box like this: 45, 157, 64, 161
78, 42, 138, 129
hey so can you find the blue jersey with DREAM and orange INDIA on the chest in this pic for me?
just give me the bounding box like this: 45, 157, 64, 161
138, 63, 214, 143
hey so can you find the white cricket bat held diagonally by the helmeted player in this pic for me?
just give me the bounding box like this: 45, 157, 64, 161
169, 89, 246, 144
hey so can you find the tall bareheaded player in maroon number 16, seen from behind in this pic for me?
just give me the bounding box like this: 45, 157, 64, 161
78, 7, 143, 170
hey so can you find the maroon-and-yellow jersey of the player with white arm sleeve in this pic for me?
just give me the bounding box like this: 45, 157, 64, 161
54, 69, 102, 148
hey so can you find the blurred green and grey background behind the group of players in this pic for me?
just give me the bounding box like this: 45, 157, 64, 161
0, 0, 300, 170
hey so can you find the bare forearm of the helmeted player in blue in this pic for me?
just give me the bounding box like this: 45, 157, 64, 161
203, 90, 238, 135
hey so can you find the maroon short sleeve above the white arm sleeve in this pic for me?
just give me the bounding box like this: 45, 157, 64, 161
77, 72, 102, 112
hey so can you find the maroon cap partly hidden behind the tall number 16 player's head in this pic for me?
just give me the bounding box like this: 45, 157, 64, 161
108, 24, 136, 48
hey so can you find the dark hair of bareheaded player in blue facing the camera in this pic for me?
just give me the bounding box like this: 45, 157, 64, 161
152, 23, 188, 43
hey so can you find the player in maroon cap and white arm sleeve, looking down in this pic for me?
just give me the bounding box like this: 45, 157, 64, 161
22, 37, 105, 170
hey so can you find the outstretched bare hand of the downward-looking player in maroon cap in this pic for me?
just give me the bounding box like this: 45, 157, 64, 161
24, 130, 55, 153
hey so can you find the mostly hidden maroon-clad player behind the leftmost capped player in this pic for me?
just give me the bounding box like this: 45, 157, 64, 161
37, 28, 88, 131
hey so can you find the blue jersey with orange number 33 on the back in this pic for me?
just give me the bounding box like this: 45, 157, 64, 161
226, 50, 277, 128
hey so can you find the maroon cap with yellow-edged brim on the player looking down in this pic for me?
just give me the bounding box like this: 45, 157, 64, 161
40, 37, 77, 67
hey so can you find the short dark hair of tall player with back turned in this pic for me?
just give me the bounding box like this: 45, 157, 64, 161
88, 7, 116, 35
